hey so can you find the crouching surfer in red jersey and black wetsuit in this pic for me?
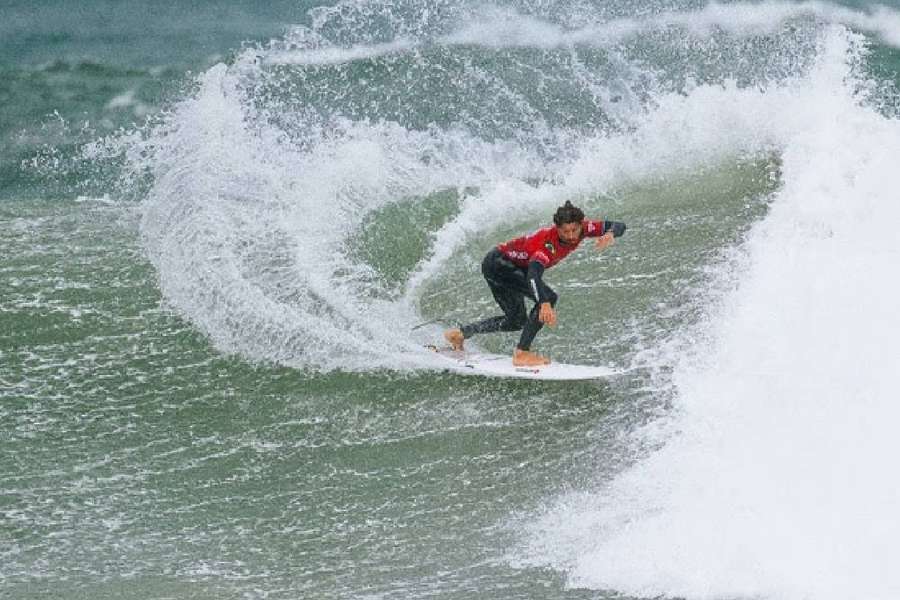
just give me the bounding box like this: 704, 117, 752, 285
444, 201, 625, 366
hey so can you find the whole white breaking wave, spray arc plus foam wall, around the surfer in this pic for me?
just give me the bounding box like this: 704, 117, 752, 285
123, 2, 900, 599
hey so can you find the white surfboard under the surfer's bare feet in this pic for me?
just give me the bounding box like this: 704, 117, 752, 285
428, 346, 621, 381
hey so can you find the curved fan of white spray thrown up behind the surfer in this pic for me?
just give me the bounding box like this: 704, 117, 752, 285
136, 58, 775, 369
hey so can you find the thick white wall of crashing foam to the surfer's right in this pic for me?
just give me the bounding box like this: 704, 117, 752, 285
519, 29, 900, 600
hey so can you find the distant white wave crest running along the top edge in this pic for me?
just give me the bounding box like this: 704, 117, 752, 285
265, 0, 900, 66
